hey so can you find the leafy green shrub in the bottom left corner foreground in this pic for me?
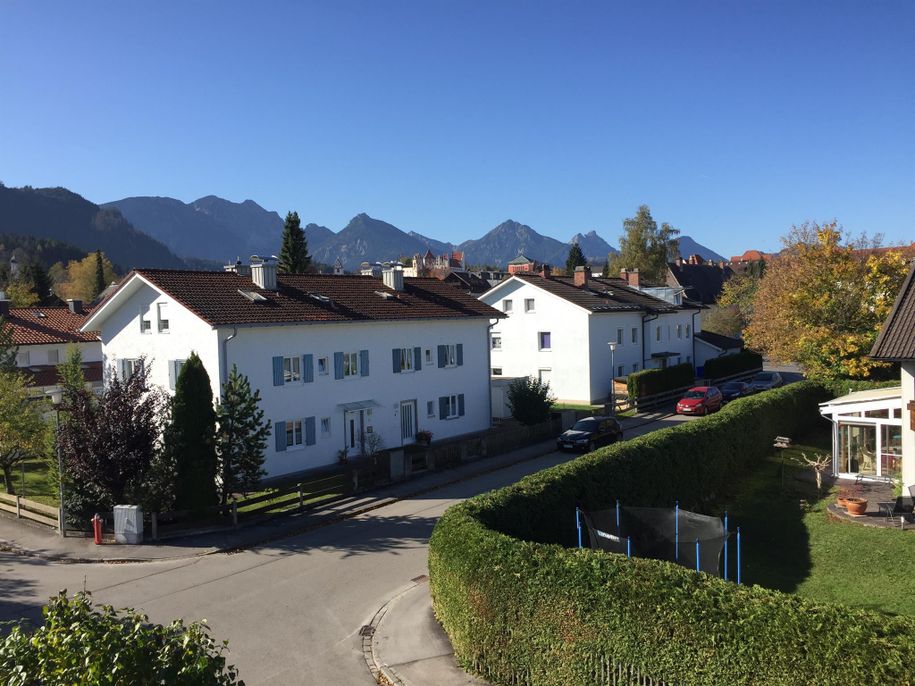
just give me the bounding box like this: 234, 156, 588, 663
0, 591, 244, 686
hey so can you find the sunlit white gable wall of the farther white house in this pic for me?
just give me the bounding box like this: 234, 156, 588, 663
480, 281, 592, 402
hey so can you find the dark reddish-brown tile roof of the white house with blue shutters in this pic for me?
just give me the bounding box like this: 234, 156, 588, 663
122, 269, 504, 326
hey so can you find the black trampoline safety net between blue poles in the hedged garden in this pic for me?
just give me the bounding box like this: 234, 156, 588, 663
581, 506, 728, 576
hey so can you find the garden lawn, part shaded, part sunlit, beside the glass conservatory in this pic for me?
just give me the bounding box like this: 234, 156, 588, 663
726, 433, 915, 615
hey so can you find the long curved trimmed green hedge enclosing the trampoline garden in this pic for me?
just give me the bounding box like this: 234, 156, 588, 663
429, 382, 915, 686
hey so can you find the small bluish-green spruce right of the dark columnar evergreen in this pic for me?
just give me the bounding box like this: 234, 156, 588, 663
216, 365, 270, 504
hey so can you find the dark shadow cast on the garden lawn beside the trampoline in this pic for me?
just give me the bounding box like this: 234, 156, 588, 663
721, 432, 829, 593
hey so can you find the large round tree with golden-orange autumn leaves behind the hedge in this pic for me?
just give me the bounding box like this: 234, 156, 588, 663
745, 222, 906, 379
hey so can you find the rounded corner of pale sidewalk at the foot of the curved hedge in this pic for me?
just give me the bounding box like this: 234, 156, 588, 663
363, 580, 487, 686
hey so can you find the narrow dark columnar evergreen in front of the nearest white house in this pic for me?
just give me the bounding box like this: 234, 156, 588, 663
165, 352, 218, 511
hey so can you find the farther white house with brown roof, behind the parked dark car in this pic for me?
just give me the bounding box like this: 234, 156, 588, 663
480, 267, 701, 403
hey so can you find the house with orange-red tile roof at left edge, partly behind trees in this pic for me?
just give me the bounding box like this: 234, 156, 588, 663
0, 296, 102, 396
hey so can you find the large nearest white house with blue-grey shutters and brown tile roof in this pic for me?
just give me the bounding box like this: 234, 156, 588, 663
85, 261, 501, 476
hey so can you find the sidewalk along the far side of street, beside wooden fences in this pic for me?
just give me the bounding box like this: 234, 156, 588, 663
0, 411, 669, 563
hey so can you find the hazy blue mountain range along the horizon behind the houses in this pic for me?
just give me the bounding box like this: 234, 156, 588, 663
0, 187, 722, 271
